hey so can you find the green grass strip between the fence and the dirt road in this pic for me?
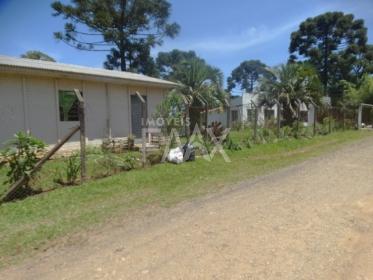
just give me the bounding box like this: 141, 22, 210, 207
0, 131, 372, 267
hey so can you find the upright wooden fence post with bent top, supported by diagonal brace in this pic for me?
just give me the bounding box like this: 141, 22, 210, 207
74, 89, 87, 183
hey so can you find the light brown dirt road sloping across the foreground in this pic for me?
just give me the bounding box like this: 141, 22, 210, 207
0, 138, 373, 280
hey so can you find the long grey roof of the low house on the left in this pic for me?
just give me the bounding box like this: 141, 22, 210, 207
0, 55, 177, 87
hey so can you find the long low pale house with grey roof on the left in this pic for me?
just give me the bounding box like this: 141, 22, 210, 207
0, 56, 176, 146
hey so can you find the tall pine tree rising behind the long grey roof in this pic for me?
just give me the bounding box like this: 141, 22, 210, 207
52, 0, 180, 74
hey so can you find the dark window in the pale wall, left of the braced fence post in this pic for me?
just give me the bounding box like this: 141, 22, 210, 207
58, 90, 79, 122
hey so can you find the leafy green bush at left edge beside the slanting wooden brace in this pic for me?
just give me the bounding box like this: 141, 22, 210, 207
1, 132, 45, 187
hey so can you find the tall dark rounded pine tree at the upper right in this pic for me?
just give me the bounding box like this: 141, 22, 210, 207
289, 12, 367, 101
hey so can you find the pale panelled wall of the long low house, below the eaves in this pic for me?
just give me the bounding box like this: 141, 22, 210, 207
0, 73, 164, 147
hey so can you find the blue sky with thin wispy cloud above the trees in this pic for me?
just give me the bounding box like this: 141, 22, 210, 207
0, 0, 373, 85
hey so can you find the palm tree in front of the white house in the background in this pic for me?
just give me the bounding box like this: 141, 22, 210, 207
259, 63, 321, 125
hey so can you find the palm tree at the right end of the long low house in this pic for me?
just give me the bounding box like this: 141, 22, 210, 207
172, 58, 227, 135
